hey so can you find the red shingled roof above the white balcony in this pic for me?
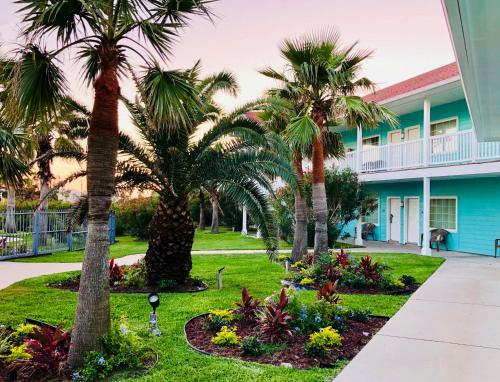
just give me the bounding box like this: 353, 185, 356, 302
363, 62, 459, 102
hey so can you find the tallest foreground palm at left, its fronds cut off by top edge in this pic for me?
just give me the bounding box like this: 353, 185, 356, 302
8, 0, 212, 367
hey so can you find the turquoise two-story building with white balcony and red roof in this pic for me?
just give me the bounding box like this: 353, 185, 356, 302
338, 63, 500, 255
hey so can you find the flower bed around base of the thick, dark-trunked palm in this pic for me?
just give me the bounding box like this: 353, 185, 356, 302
48, 259, 208, 293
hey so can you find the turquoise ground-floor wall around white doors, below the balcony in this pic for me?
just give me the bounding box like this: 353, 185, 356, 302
346, 177, 500, 256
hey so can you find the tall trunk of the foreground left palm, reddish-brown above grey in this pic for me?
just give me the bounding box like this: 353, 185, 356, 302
68, 56, 120, 367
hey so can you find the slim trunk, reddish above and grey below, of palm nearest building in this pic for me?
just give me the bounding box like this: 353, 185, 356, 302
312, 110, 328, 258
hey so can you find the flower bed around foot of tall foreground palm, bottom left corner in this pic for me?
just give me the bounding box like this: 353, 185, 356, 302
0, 324, 157, 382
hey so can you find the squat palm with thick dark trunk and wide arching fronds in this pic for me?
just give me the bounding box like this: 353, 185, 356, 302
117, 68, 297, 285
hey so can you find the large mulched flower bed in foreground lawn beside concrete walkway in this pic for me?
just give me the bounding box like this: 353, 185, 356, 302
185, 283, 387, 368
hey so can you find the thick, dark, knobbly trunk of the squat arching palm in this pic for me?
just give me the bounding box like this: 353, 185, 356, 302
145, 198, 195, 285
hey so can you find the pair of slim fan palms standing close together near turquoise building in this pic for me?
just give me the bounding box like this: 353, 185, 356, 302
261, 29, 397, 260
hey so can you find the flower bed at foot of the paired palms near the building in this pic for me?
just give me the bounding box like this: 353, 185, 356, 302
278, 250, 419, 294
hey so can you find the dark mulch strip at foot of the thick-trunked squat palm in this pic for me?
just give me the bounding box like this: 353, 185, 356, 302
47, 277, 208, 293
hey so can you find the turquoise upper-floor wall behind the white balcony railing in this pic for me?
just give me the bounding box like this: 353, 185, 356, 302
342, 99, 472, 150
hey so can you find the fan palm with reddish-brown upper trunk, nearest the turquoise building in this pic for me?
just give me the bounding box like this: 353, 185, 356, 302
261, 30, 396, 256
